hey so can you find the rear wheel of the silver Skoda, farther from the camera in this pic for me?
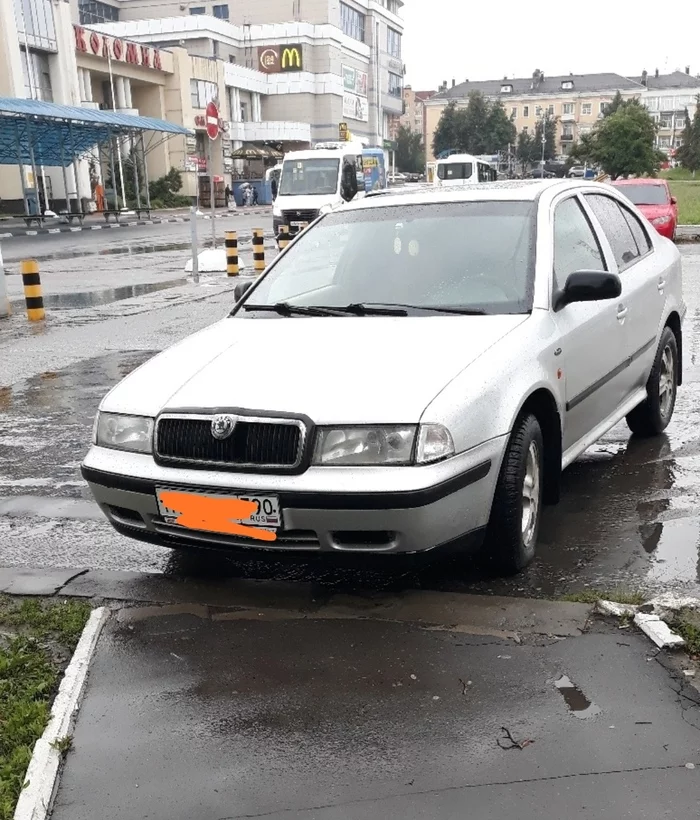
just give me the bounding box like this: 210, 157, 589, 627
627, 327, 678, 437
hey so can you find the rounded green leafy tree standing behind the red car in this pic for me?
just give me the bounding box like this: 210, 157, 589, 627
575, 99, 663, 179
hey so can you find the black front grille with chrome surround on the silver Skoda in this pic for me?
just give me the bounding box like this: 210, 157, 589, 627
155, 414, 306, 469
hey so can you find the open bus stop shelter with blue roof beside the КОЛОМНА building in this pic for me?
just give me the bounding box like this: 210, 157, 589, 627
0, 97, 192, 215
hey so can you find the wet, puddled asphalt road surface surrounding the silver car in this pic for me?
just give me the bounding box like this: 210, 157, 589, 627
0, 237, 700, 597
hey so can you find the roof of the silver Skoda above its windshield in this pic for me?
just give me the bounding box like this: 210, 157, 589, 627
346, 179, 590, 210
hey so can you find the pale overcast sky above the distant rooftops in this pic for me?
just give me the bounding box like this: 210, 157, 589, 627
403, 0, 700, 90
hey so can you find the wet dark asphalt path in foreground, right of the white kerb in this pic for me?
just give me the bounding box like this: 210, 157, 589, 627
53, 606, 700, 820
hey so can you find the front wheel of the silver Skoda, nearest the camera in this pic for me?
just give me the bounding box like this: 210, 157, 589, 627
485, 413, 544, 575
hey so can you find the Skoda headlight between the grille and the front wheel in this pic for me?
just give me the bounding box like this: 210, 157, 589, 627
313, 424, 454, 467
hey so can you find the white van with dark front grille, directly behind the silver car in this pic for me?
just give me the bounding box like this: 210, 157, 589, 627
272, 142, 387, 236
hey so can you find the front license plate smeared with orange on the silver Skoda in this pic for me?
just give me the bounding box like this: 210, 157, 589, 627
156, 488, 282, 534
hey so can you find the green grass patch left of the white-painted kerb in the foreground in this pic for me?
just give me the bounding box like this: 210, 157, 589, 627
0, 596, 90, 820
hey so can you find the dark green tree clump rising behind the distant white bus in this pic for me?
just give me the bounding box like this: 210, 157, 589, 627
433, 91, 516, 156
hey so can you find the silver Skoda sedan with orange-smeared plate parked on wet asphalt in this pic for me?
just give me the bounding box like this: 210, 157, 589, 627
83, 180, 685, 573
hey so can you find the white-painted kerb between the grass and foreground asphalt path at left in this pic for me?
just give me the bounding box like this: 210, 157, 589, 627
14, 607, 110, 820
